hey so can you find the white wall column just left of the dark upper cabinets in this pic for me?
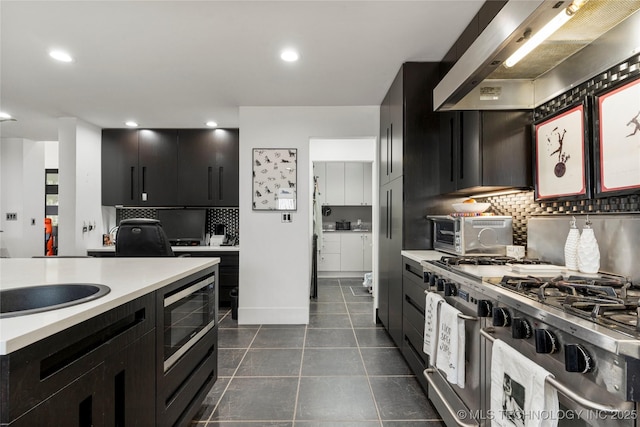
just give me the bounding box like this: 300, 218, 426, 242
58, 117, 103, 255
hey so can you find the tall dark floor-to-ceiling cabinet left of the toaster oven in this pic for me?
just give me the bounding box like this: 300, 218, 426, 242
377, 62, 440, 348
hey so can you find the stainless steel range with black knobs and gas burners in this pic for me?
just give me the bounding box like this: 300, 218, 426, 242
422, 256, 640, 426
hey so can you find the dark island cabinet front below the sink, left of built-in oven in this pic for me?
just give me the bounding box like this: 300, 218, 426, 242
0, 294, 156, 426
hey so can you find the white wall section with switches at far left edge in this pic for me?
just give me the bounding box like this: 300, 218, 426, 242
0, 138, 45, 258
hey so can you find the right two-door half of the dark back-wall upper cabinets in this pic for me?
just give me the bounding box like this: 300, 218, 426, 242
178, 129, 239, 207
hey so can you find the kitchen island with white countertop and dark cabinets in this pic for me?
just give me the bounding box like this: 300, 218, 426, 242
0, 257, 219, 426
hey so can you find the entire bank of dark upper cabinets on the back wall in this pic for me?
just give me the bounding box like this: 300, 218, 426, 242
102, 129, 239, 207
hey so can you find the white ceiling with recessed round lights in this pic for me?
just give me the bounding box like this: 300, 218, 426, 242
0, 0, 483, 140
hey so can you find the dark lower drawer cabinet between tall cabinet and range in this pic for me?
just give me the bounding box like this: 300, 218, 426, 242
400, 257, 428, 391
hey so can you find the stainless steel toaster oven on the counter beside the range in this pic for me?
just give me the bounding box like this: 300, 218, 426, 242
427, 215, 513, 255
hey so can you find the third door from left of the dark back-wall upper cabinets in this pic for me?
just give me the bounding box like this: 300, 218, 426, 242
178, 129, 215, 206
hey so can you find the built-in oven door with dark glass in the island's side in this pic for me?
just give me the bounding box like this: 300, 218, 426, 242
163, 275, 216, 372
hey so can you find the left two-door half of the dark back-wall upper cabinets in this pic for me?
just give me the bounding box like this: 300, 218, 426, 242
102, 129, 178, 206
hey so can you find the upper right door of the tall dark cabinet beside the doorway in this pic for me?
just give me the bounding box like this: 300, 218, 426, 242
389, 68, 404, 181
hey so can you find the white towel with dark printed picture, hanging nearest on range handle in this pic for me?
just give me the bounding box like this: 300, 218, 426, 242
491, 340, 559, 427
